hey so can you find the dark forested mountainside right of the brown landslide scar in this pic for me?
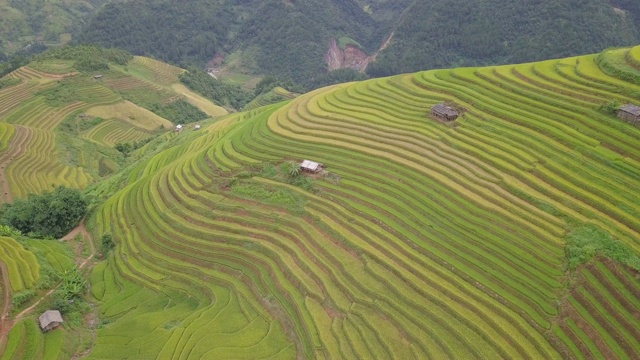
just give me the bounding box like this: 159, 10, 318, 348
368, 0, 640, 76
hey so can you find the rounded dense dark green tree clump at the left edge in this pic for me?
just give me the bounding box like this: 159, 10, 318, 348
0, 187, 88, 238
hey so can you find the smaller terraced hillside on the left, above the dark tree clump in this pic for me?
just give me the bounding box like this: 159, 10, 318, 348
0, 47, 227, 203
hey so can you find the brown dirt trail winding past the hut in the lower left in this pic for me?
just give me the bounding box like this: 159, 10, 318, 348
0, 220, 96, 356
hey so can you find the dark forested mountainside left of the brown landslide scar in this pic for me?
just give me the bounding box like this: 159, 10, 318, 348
79, 0, 375, 82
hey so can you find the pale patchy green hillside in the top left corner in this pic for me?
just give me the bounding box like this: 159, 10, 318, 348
0, 0, 108, 54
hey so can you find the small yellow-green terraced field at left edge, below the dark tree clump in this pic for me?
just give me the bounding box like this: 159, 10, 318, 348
0, 236, 40, 292
